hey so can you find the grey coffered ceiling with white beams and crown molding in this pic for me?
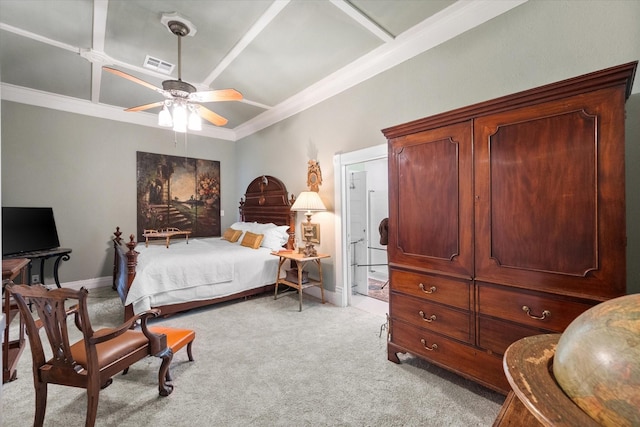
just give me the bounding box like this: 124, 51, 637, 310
0, 0, 525, 140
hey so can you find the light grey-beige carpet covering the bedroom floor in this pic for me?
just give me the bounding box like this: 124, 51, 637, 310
0, 289, 504, 427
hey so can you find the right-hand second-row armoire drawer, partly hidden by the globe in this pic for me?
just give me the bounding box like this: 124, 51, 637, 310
478, 316, 550, 356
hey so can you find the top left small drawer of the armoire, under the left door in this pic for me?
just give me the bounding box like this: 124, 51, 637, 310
390, 269, 470, 310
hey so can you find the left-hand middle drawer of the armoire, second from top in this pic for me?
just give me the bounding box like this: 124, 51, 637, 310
390, 293, 473, 343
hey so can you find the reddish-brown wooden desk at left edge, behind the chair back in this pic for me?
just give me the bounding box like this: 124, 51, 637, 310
2, 258, 31, 383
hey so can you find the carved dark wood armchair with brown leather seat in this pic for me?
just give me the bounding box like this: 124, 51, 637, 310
7, 285, 173, 427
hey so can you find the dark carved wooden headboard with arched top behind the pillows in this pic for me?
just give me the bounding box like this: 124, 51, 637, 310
239, 175, 296, 249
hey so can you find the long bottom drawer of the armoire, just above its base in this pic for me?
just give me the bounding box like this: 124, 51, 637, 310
388, 320, 510, 394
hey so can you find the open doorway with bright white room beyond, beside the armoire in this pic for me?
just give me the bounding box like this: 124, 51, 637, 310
335, 145, 389, 314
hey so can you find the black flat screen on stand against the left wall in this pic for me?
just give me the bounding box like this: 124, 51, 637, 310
2, 206, 60, 256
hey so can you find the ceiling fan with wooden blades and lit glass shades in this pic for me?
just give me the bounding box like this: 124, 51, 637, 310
102, 20, 242, 132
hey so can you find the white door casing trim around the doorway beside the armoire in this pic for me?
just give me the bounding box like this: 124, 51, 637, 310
333, 144, 387, 307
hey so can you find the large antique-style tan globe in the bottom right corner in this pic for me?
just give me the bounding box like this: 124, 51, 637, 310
553, 294, 640, 427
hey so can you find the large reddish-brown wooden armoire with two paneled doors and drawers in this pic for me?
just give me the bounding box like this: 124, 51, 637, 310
382, 62, 637, 393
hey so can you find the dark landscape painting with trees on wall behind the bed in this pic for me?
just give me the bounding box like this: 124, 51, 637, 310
136, 151, 221, 241
